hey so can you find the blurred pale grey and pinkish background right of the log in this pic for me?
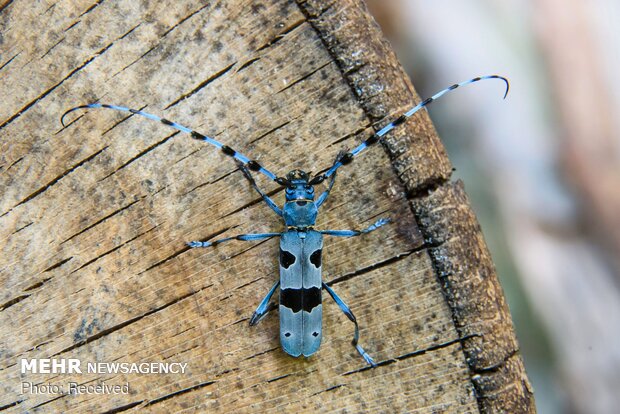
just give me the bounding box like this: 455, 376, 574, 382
368, 0, 620, 414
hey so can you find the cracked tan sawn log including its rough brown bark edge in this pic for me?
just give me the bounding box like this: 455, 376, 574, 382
0, 0, 535, 413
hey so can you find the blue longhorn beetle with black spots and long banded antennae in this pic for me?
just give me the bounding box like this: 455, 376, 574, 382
60, 75, 510, 367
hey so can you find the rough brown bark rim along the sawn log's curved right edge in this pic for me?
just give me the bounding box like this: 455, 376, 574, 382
298, 0, 536, 413
